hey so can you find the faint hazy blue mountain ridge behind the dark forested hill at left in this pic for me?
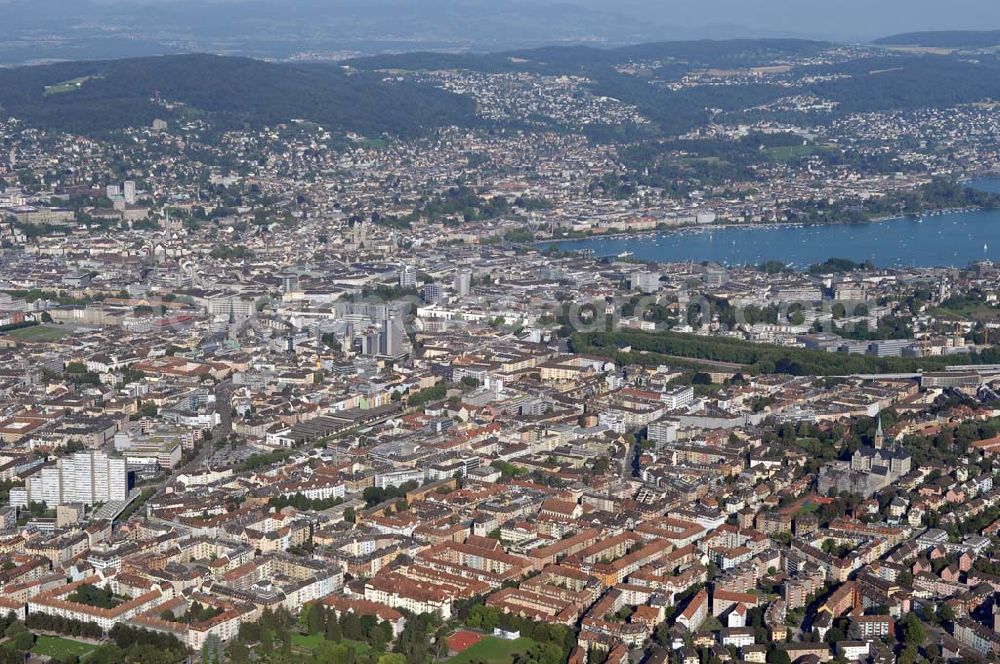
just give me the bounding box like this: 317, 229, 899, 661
0, 0, 684, 64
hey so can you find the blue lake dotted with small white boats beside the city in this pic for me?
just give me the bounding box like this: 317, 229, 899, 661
544, 180, 1000, 268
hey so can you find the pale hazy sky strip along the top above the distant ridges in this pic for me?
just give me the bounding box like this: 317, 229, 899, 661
0, 0, 1000, 40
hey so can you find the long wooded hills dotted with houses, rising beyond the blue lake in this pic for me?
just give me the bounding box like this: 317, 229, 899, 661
346, 39, 1000, 141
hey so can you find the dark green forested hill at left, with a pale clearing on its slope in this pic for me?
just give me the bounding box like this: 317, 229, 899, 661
0, 55, 476, 136
